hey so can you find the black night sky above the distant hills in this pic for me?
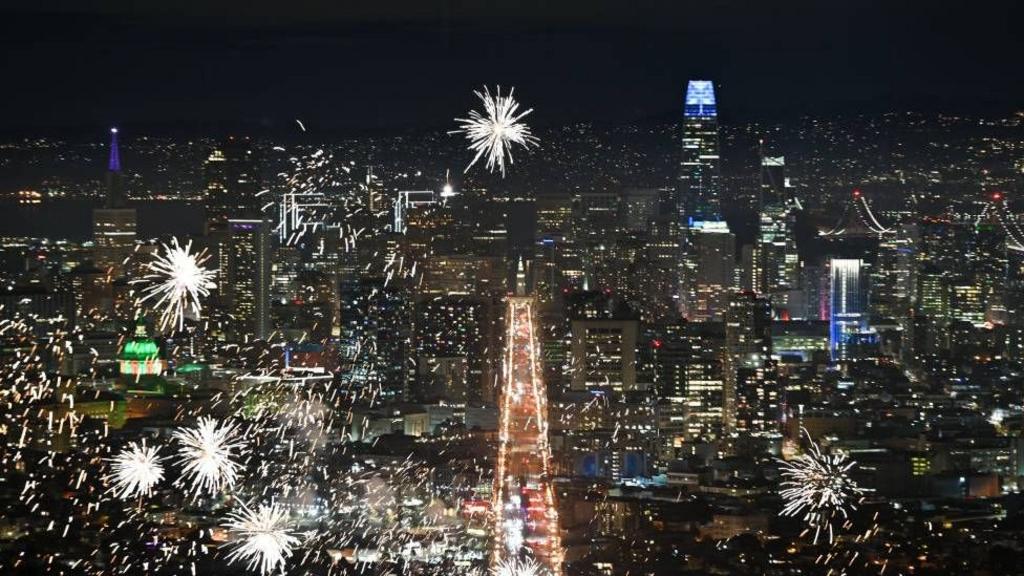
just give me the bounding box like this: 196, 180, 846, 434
0, 0, 1024, 133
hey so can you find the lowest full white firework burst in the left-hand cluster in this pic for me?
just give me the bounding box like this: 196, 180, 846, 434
224, 503, 299, 574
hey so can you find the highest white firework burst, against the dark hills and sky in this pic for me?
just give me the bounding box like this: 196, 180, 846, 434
449, 86, 540, 177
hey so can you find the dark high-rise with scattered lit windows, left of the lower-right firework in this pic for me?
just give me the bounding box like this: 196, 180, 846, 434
723, 292, 781, 437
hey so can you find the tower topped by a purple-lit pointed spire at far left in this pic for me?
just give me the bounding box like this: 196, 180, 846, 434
92, 128, 136, 278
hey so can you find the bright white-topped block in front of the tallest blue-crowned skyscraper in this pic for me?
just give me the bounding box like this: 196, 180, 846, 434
680, 220, 736, 322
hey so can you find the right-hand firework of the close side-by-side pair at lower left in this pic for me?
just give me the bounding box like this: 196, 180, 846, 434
174, 416, 244, 495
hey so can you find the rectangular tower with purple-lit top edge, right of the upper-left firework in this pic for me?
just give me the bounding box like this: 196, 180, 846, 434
226, 218, 271, 341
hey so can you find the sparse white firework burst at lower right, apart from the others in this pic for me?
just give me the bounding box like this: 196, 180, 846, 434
779, 429, 863, 544
